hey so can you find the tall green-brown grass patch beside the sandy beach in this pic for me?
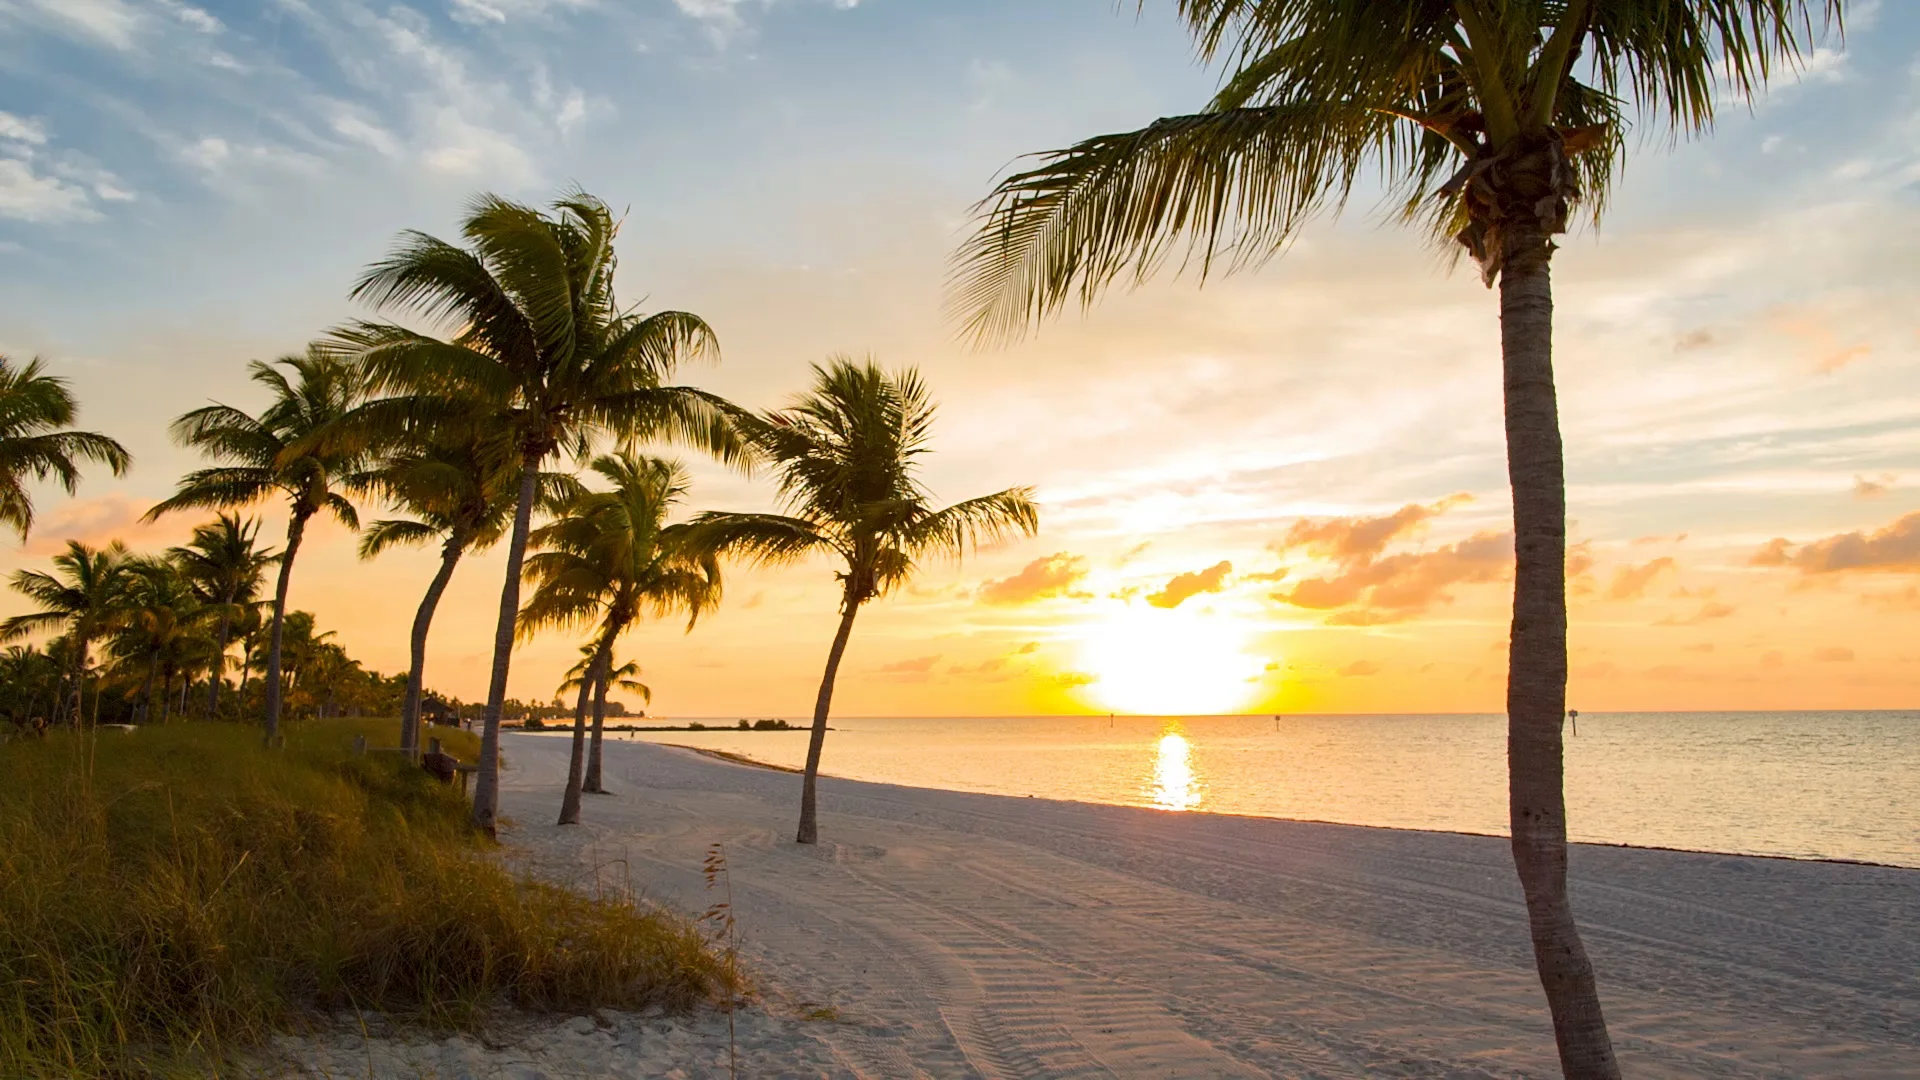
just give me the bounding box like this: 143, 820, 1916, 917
0, 721, 728, 1080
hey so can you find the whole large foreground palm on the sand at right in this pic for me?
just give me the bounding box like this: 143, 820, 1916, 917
954, 0, 1843, 1078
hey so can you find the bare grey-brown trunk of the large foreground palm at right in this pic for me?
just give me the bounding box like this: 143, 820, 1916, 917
1500, 229, 1620, 1080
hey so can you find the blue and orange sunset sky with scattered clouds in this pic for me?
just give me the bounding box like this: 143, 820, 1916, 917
0, 0, 1920, 717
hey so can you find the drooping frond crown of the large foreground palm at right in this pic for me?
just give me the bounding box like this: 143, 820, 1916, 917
954, 0, 1843, 338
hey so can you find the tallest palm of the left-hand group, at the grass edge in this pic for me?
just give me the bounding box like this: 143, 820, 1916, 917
332, 192, 741, 834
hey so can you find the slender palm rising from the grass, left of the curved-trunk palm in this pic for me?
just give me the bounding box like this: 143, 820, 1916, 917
144, 348, 361, 742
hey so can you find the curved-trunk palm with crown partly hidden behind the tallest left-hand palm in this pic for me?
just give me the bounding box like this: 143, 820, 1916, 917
355, 425, 572, 755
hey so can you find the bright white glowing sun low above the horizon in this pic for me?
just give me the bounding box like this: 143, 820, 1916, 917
1079, 603, 1263, 717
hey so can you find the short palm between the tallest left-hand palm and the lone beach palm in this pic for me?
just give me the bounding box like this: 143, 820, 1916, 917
520, 452, 720, 824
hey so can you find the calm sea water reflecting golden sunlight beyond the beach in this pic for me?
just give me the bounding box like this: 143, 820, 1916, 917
591, 713, 1920, 867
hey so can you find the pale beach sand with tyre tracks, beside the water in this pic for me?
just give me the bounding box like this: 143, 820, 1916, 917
263, 736, 1920, 1080
